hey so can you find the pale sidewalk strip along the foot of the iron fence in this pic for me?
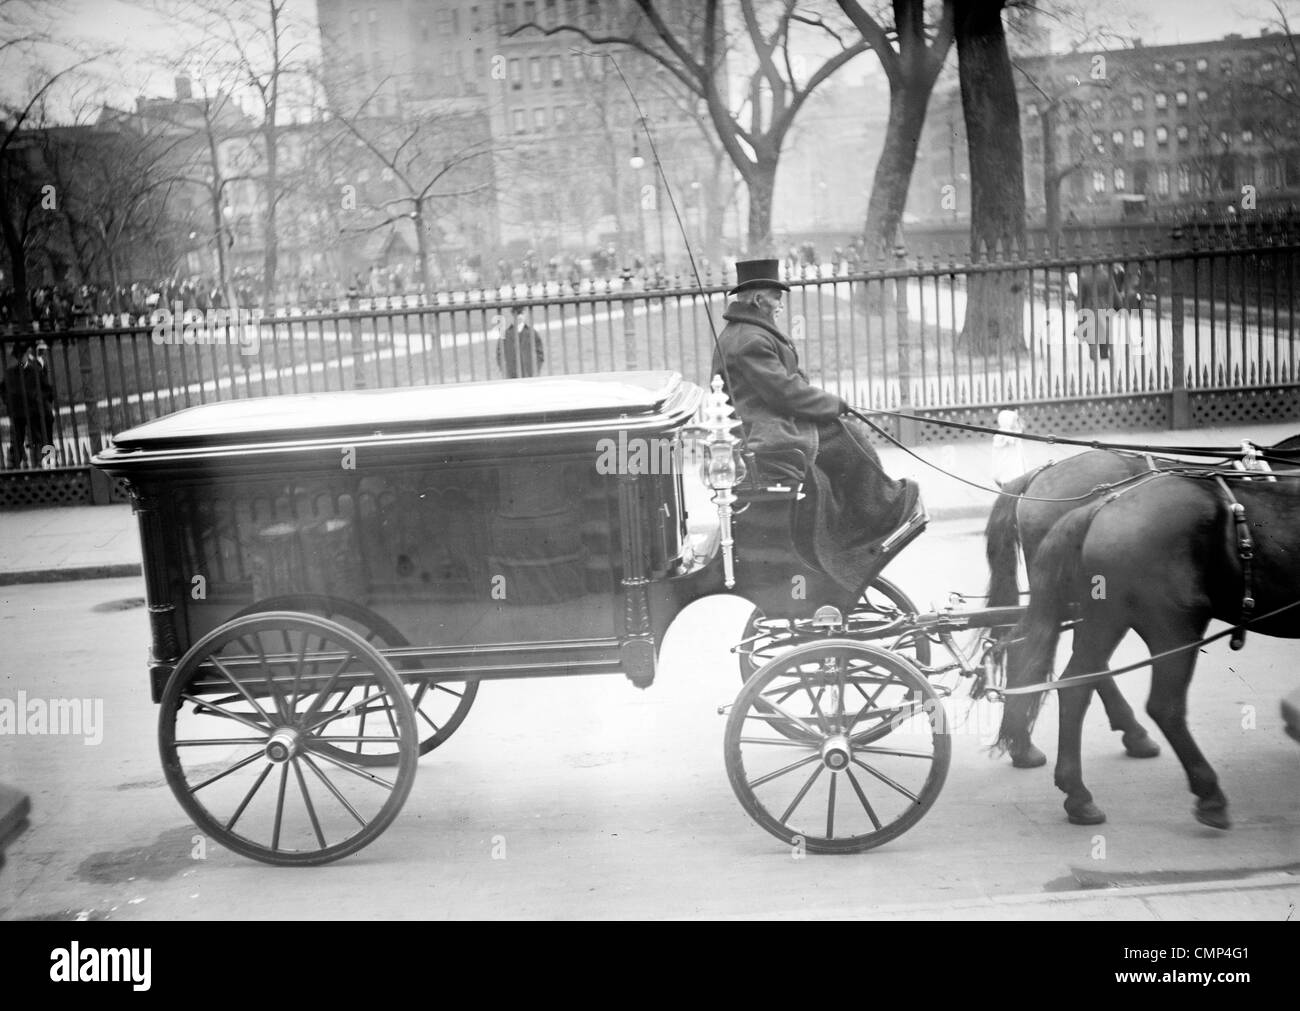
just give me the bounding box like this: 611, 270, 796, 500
0, 421, 1300, 586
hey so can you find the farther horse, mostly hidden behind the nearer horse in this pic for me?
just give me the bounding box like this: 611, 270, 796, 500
984, 435, 1300, 769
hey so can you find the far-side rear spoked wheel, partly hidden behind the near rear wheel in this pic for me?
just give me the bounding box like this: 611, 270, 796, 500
237, 594, 478, 765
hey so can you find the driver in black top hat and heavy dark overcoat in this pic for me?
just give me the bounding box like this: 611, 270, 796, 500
712, 259, 919, 563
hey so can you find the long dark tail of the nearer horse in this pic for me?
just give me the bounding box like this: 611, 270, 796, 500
993, 500, 1105, 752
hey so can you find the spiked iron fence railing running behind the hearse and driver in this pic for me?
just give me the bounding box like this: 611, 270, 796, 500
0, 224, 1300, 470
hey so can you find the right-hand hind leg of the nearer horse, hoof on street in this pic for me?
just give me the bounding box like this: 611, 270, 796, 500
1143, 621, 1232, 829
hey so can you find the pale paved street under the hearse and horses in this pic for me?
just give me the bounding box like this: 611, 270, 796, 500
0, 520, 1300, 920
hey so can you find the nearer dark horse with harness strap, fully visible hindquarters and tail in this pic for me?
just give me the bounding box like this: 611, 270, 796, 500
998, 474, 1300, 828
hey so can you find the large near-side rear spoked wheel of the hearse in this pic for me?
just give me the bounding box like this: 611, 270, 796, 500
159, 611, 420, 865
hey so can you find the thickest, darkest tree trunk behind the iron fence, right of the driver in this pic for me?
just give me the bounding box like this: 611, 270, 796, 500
956, 0, 1024, 353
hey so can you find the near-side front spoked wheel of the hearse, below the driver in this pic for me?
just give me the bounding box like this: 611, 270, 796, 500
724, 639, 952, 852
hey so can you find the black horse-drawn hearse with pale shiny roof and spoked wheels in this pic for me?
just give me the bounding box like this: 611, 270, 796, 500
96, 372, 1034, 864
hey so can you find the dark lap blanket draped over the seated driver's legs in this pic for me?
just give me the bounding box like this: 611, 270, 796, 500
793, 418, 920, 594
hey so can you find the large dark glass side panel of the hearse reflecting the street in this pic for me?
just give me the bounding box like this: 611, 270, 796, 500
172, 459, 629, 646
